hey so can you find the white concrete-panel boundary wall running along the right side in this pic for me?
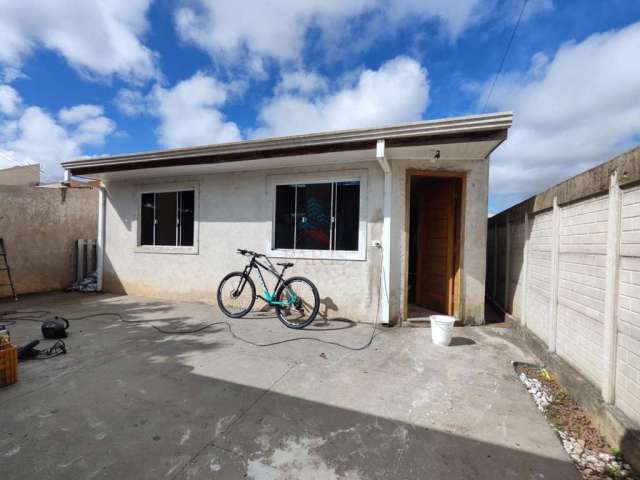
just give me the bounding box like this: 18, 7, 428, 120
488, 150, 640, 425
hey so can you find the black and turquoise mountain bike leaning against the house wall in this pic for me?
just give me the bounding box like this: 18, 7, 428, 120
217, 249, 320, 329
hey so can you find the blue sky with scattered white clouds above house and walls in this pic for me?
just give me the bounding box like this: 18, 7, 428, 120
0, 0, 640, 212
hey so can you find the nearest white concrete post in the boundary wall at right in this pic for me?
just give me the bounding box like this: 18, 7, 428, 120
602, 171, 622, 403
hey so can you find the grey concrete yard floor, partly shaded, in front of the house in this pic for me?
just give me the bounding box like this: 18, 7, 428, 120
0, 293, 579, 480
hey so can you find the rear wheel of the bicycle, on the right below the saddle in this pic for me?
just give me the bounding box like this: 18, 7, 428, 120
276, 277, 320, 329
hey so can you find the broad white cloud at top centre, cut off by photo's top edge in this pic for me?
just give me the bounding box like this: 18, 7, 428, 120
176, 0, 480, 71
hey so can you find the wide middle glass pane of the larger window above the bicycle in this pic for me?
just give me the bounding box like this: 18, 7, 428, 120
295, 183, 331, 250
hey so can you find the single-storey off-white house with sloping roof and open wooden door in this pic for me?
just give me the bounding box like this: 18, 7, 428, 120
58, 112, 512, 324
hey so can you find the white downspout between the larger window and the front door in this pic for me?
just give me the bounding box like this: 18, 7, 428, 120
376, 139, 392, 325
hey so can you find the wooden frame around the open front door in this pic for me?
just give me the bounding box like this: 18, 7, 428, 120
402, 169, 467, 321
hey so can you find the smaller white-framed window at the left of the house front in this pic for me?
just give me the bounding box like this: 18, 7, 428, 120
140, 190, 195, 247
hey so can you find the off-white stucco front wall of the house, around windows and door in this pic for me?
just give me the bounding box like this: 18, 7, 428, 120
104, 156, 488, 323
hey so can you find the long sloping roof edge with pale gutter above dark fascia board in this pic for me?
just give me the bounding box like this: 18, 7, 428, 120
62, 112, 513, 178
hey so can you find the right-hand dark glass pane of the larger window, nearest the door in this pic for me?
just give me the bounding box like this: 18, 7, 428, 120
334, 181, 360, 250
